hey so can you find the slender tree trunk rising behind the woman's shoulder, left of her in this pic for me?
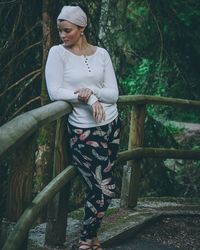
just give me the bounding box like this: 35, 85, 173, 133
35, 0, 56, 222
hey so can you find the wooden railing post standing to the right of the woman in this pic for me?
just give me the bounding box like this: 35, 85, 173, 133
121, 104, 146, 207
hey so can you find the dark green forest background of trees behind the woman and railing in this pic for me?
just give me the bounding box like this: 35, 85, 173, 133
0, 0, 200, 217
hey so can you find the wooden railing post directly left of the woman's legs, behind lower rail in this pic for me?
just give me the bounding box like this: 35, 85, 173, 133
45, 117, 70, 246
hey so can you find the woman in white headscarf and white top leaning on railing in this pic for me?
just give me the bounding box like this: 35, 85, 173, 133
45, 5, 120, 250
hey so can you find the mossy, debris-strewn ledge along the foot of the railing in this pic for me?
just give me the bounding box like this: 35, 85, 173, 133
29, 198, 200, 250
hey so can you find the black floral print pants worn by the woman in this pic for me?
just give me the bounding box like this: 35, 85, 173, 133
68, 117, 120, 241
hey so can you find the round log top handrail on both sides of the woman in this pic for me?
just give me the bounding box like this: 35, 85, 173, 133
0, 95, 200, 158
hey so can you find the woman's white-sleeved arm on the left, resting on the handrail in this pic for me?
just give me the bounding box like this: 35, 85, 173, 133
45, 46, 79, 102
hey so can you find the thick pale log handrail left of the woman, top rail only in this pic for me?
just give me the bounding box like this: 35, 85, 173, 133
0, 101, 71, 159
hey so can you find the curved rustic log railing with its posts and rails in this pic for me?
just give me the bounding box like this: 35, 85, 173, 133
0, 95, 200, 250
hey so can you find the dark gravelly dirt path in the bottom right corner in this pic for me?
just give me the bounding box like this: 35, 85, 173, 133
105, 216, 200, 250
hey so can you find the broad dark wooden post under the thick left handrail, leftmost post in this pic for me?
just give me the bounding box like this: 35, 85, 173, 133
1, 134, 36, 250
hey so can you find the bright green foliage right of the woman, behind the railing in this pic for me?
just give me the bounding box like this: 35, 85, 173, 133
117, 0, 200, 199
